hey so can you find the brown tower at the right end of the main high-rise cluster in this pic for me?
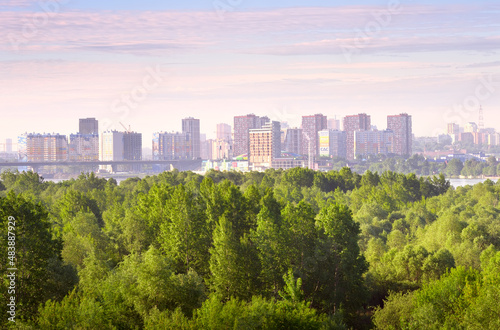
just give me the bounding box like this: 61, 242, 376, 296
387, 113, 413, 156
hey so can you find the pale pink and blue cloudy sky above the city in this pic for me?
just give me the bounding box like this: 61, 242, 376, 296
0, 0, 500, 149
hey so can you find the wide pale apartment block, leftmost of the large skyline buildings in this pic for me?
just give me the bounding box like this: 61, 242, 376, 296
26, 133, 68, 162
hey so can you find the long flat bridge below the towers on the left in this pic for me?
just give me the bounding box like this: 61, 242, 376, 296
0, 159, 202, 172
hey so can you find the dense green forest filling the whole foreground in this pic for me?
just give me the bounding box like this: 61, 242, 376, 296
0, 167, 500, 329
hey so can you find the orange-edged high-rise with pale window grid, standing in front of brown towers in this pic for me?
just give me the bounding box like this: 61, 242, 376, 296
248, 121, 281, 167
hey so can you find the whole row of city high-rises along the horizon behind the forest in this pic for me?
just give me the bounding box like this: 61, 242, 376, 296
7, 113, 500, 172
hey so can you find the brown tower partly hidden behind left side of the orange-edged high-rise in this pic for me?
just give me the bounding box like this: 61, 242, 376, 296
233, 114, 269, 157
